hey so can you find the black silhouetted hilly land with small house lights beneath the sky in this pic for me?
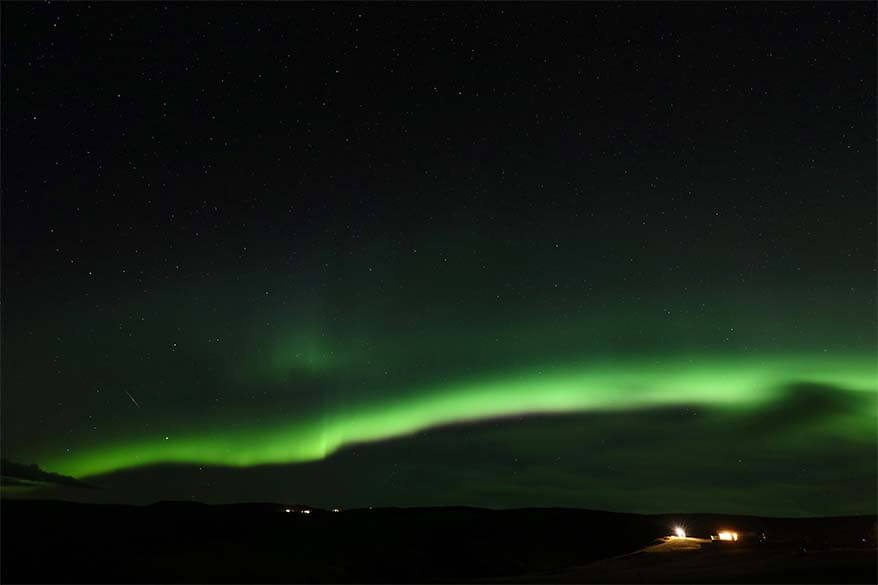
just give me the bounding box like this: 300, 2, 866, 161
2, 500, 876, 583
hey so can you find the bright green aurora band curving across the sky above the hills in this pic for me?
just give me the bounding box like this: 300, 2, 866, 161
42, 355, 878, 477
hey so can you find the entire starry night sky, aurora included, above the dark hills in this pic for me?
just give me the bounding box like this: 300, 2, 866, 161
0, 2, 878, 515
